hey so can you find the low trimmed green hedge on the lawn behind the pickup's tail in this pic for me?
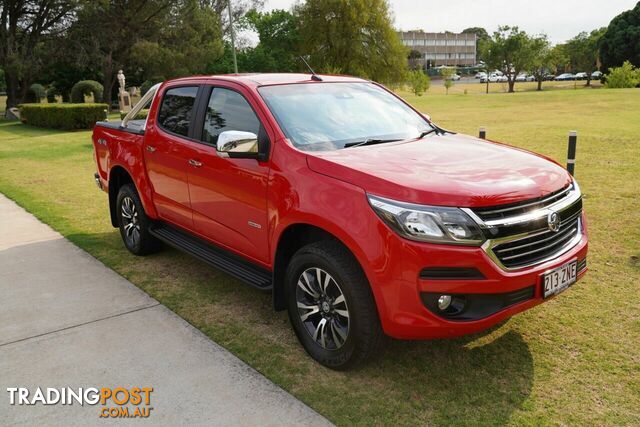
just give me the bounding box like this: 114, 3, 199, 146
20, 104, 108, 130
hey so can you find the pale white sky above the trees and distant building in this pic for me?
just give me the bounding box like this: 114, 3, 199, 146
265, 0, 638, 43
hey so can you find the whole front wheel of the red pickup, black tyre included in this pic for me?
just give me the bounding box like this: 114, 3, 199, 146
285, 241, 383, 370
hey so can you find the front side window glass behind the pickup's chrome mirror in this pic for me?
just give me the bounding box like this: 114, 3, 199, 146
202, 88, 260, 145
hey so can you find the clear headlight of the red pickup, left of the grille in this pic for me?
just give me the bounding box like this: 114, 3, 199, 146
367, 195, 485, 246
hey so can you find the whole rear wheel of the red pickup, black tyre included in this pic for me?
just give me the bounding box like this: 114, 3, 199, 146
116, 184, 161, 255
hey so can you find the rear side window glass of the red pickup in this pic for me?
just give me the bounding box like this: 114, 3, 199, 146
158, 86, 198, 136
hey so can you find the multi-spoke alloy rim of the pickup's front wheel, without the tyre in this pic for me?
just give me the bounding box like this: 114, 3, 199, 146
296, 267, 350, 350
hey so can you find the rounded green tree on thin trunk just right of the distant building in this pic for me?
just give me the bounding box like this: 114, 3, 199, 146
482, 26, 539, 93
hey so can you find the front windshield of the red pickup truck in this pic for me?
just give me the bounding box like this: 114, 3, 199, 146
259, 83, 432, 151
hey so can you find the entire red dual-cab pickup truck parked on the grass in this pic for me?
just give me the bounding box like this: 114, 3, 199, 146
93, 74, 587, 369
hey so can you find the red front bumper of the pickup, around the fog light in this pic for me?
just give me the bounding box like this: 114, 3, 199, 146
372, 214, 588, 339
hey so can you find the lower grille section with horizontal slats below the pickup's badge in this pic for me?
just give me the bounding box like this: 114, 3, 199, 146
493, 216, 580, 268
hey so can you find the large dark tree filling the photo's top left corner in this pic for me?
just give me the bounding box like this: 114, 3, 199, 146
0, 0, 79, 110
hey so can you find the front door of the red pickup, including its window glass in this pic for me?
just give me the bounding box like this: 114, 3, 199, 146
189, 87, 269, 264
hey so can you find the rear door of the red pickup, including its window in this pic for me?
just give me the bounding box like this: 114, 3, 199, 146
144, 85, 201, 230
